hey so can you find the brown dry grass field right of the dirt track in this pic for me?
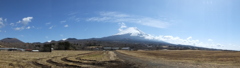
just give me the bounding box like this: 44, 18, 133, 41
119, 50, 240, 66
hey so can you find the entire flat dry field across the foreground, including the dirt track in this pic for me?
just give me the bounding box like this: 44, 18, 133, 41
0, 50, 240, 68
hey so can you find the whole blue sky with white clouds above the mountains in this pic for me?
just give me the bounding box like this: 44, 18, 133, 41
0, 0, 240, 50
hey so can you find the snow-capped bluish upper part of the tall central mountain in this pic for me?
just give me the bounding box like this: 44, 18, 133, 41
91, 27, 170, 45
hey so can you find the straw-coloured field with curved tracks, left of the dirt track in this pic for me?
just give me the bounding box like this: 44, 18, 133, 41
0, 51, 135, 68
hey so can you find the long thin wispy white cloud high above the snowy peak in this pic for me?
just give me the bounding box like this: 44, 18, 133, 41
87, 12, 170, 28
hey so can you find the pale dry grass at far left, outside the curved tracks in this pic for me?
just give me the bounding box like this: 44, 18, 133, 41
0, 51, 91, 68
